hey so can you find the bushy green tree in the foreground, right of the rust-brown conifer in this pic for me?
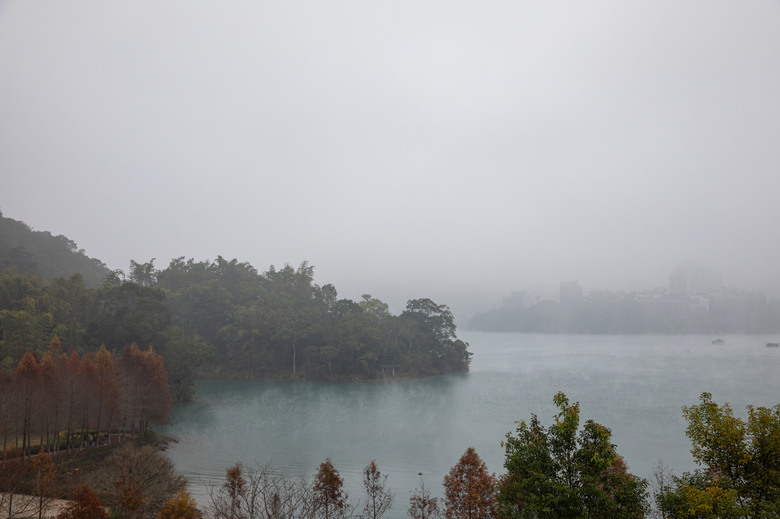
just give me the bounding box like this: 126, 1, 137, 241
498, 393, 647, 519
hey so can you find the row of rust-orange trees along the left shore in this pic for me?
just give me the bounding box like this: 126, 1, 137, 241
0, 336, 171, 459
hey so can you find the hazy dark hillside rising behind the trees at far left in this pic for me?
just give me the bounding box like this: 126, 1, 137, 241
0, 212, 108, 288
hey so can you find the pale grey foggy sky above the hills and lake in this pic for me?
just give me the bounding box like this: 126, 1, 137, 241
0, 0, 780, 311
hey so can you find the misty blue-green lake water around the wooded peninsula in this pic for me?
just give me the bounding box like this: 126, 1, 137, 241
163, 332, 780, 518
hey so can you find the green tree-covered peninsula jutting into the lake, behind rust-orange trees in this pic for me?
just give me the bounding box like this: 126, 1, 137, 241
0, 257, 470, 400
